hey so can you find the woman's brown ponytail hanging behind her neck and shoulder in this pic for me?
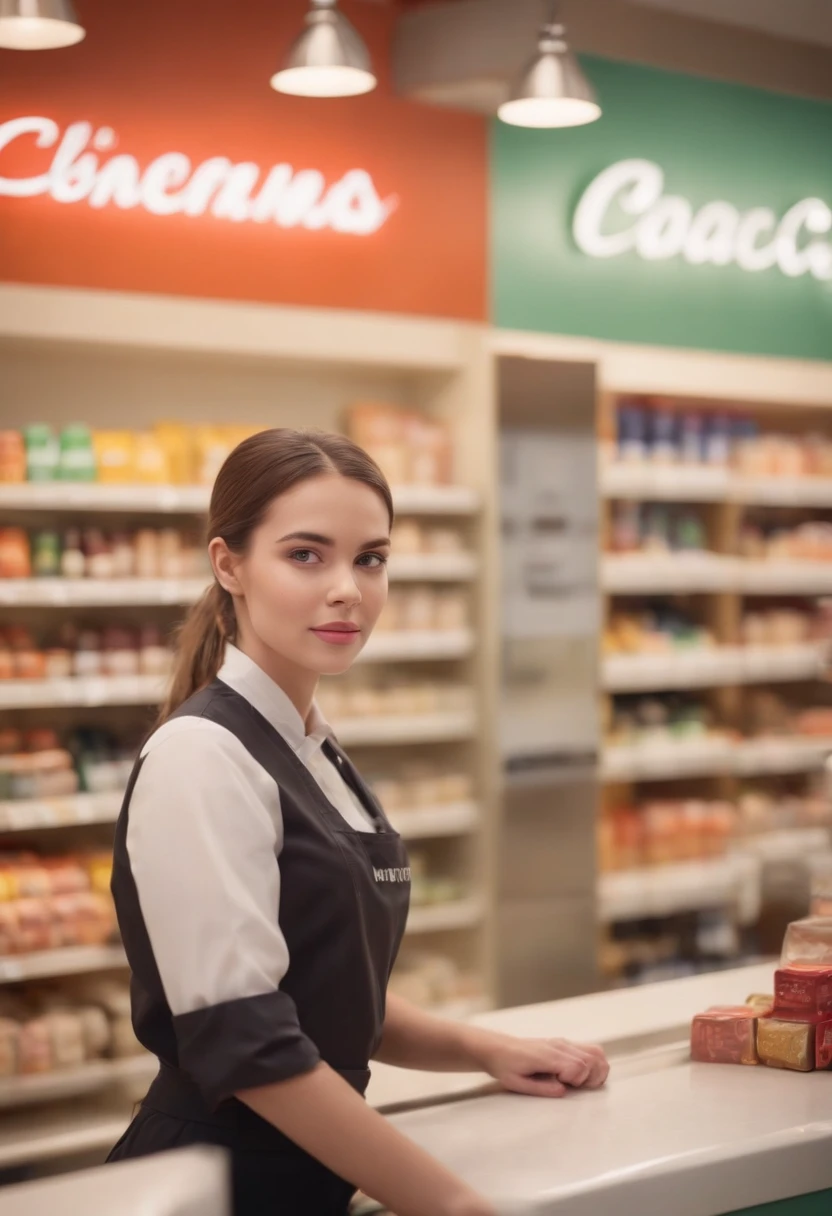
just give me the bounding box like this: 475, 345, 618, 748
156, 581, 235, 727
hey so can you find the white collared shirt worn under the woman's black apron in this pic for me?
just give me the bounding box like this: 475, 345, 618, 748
127, 646, 376, 1017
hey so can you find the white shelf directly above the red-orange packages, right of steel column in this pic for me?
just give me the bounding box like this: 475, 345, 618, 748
601, 737, 832, 782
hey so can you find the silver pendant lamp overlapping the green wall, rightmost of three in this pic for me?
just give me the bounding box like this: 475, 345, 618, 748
497, 0, 601, 126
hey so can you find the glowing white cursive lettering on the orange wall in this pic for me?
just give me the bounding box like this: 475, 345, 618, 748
0, 116, 397, 236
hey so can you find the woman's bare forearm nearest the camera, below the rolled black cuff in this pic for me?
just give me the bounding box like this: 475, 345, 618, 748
237, 1064, 495, 1216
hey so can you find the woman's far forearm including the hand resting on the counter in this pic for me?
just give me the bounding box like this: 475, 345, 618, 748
376, 992, 609, 1098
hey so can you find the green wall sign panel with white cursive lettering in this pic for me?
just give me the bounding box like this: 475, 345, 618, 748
491, 56, 832, 360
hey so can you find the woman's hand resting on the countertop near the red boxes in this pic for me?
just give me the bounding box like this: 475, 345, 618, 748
478, 1035, 609, 1098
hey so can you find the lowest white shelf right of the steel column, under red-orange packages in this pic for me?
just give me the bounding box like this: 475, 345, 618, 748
598, 856, 760, 924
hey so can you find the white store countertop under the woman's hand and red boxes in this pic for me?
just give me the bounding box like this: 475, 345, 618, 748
372, 964, 832, 1216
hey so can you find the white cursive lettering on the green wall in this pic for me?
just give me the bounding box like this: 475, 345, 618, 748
572, 159, 832, 282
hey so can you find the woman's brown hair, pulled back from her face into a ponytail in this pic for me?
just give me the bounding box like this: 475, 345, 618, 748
157, 427, 393, 726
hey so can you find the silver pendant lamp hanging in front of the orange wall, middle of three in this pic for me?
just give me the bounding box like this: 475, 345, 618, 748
271, 0, 377, 97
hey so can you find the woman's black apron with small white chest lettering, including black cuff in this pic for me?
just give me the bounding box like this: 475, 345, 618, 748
108, 680, 410, 1216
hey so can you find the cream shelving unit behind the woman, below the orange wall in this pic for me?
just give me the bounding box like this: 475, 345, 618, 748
0, 279, 497, 1152
